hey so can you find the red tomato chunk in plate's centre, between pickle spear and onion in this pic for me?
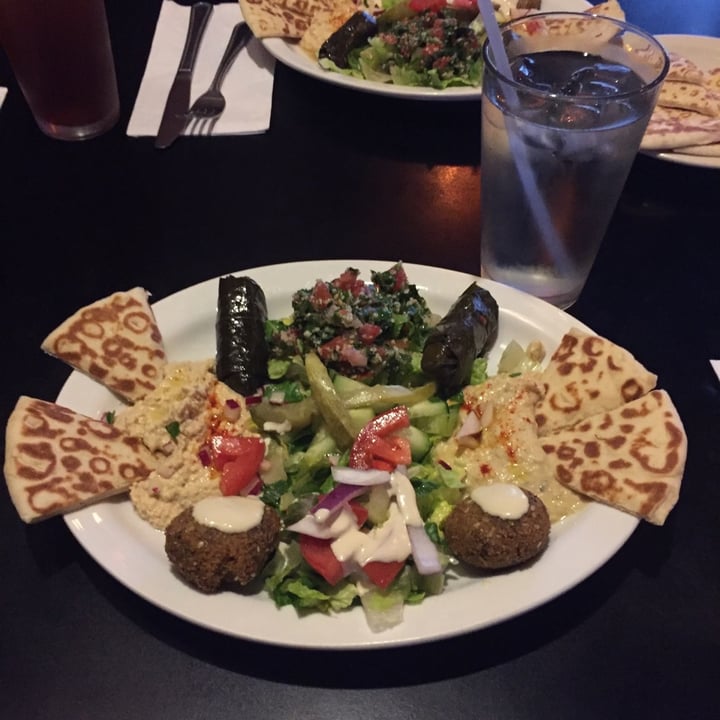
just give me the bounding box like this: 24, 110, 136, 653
348, 405, 410, 470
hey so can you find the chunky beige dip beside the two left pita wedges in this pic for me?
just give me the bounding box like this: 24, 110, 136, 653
115, 360, 252, 529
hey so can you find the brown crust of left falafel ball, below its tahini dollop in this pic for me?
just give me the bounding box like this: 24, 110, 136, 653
165, 498, 280, 593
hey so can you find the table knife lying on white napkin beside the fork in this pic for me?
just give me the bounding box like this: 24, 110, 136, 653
155, 2, 213, 149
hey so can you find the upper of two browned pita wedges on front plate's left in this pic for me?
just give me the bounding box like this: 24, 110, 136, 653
41, 287, 167, 403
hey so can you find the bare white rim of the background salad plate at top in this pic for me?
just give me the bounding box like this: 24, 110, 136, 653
262, 0, 590, 100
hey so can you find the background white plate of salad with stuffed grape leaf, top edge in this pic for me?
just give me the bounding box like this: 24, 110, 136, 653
256, 0, 590, 101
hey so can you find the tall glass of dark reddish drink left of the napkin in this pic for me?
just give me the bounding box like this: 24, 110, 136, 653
0, 0, 120, 140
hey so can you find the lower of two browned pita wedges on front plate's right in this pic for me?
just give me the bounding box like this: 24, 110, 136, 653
543, 390, 687, 525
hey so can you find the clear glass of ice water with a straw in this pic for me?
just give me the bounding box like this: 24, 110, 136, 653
481, 13, 669, 308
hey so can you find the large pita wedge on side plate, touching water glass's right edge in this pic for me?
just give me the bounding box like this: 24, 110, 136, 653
640, 106, 720, 150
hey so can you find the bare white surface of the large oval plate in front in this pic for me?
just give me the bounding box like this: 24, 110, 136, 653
57, 260, 637, 649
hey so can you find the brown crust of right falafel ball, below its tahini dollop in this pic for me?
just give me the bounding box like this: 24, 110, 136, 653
443, 489, 550, 570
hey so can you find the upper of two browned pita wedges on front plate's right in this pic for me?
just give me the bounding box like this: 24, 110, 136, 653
535, 328, 657, 437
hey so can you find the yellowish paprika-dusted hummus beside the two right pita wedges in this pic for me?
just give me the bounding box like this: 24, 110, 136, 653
435, 373, 585, 522
